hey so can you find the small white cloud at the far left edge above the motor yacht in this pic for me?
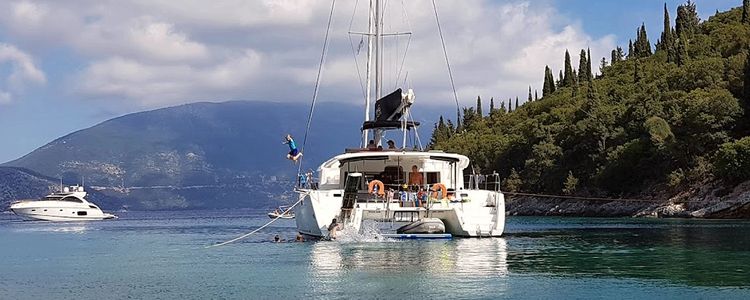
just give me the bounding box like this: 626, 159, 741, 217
0, 43, 47, 104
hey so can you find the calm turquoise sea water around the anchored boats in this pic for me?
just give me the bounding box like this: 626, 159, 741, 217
0, 210, 750, 299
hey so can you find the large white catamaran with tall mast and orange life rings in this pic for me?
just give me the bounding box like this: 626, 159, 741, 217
295, 0, 505, 238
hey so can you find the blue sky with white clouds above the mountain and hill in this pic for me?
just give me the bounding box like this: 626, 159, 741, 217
0, 0, 742, 162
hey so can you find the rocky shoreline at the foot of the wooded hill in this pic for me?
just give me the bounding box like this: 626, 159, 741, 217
506, 181, 750, 219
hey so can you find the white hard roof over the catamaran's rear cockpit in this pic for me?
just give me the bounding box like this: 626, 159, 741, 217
320, 149, 469, 169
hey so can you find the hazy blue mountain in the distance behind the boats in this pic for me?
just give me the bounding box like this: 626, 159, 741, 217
4, 101, 450, 209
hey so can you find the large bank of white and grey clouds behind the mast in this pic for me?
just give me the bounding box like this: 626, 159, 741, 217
0, 0, 614, 109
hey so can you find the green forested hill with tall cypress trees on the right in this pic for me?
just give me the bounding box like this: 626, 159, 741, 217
432, 0, 750, 200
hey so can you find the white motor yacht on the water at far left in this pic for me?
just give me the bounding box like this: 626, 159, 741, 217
10, 186, 117, 221
